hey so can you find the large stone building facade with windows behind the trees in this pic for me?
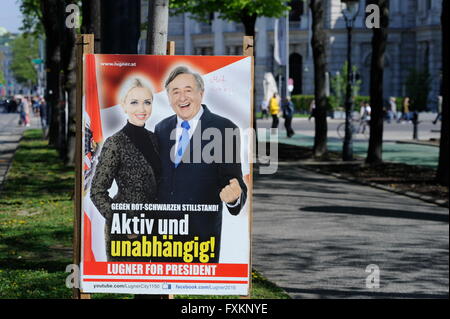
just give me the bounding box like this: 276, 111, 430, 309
141, 0, 442, 110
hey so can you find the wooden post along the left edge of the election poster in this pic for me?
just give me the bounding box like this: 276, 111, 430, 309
72, 34, 94, 299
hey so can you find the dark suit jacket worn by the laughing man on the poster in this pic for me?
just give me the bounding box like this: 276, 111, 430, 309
155, 105, 247, 262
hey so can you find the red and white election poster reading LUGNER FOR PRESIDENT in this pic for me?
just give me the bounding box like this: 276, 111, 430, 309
80, 54, 252, 295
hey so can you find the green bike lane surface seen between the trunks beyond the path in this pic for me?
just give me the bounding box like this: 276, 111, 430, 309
258, 130, 439, 168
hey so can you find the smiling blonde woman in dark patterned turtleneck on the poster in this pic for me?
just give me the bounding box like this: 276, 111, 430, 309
91, 79, 161, 261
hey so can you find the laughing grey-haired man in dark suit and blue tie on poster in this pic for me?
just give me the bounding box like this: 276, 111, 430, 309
155, 66, 247, 262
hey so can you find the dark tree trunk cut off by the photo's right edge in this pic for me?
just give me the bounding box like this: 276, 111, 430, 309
436, 0, 450, 186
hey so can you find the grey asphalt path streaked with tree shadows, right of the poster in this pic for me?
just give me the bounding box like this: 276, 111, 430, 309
253, 165, 449, 298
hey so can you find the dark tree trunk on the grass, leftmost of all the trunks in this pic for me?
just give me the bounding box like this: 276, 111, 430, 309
40, 0, 64, 148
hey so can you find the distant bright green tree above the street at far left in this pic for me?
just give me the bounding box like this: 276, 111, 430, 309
11, 34, 38, 85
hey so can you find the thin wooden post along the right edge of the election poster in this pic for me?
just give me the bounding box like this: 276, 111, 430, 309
242, 36, 256, 298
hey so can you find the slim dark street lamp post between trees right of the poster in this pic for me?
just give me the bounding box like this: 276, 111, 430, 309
341, 0, 359, 161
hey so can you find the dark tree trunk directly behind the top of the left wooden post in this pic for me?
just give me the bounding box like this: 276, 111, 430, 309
81, 0, 101, 53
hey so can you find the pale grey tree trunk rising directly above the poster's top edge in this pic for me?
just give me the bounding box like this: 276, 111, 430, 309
145, 0, 169, 55
